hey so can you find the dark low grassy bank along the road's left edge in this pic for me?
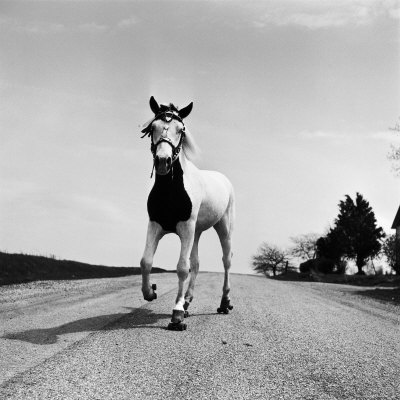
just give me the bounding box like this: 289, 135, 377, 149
0, 252, 167, 285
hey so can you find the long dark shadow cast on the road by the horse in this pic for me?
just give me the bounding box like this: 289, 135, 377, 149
1, 308, 171, 345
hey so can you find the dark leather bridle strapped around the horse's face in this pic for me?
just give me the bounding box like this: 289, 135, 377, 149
141, 108, 186, 177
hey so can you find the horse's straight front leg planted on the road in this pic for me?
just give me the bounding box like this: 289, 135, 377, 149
168, 221, 195, 331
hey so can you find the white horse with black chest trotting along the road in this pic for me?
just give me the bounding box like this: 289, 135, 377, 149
140, 96, 235, 331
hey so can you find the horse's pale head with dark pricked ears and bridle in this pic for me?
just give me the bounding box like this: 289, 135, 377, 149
142, 96, 193, 175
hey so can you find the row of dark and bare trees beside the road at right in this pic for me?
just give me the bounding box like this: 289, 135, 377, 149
252, 193, 400, 276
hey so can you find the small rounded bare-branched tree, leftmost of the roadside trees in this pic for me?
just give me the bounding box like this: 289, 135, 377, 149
252, 242, 289, 276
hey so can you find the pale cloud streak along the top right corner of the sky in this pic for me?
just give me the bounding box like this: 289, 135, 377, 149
253, 0, 400, 30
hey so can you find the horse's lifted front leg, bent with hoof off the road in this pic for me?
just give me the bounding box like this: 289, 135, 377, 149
140, 221, 163, 301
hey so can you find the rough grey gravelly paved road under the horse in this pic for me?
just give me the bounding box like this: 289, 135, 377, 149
0, 273, 400, 400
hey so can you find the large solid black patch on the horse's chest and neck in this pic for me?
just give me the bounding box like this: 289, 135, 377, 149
147, 159, 192, 232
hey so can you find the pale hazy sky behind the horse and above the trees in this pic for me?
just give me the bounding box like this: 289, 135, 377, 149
0, 0, 400, 273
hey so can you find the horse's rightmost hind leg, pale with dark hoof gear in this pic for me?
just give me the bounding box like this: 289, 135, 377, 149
214, 212, 233, 314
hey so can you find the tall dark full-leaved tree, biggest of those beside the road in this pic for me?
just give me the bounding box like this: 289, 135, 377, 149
334, 193, 385, 275
